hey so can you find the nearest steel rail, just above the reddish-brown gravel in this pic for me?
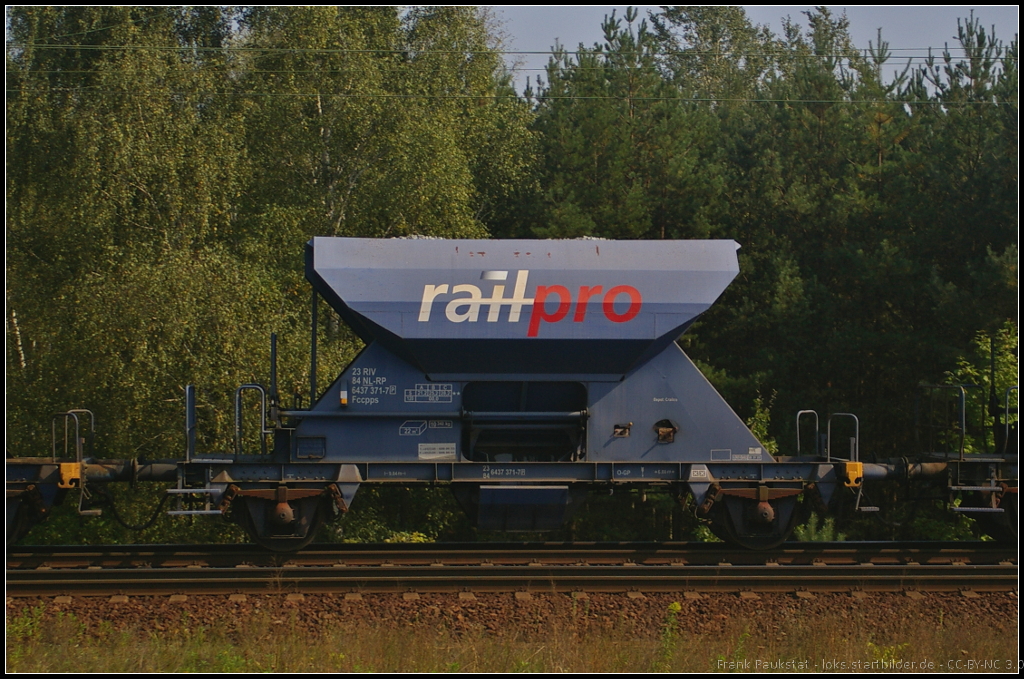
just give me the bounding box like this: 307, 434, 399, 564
7, 564, 1018, 596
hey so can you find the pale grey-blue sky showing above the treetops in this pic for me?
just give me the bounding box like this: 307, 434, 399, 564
495, 5, 1020, 92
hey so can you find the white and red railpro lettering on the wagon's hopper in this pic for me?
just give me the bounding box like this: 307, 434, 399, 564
420, 269, 643, 337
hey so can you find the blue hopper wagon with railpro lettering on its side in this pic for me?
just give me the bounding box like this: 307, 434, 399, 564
8, 238, 1016, 550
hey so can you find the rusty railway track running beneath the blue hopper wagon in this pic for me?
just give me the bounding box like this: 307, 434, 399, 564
6, 542, 1018, 596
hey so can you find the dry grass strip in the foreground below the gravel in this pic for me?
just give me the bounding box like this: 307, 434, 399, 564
6, 603, 1018, 673
